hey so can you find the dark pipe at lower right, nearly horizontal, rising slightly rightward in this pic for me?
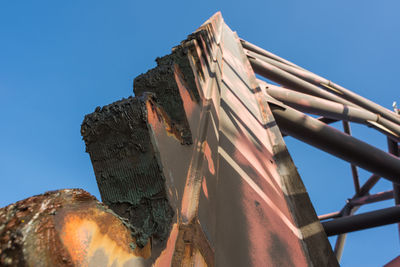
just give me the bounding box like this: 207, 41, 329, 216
322, 206, 400, 236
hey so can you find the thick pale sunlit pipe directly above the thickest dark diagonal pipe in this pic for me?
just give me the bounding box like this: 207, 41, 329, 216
265, 83, 400, 141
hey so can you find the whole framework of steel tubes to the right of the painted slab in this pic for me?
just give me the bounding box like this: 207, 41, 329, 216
241, 39, 400, 261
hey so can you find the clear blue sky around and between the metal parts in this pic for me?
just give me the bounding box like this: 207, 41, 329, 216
0, 0, 400, 266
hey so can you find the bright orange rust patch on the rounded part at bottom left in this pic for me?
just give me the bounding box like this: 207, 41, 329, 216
57, 205, 151, 266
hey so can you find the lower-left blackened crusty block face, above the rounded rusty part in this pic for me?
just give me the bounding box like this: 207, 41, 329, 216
81, 96, 173, 247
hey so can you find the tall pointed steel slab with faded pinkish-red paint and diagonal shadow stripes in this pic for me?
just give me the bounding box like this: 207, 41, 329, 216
78, 13, 337, 266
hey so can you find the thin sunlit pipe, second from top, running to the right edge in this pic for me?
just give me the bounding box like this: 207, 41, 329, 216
248, 48, 400, 124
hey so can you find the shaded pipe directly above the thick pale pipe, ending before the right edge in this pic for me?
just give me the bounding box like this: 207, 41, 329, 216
248, 57, 355, 106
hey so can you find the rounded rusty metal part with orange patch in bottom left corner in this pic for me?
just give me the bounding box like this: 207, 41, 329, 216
0, 189, 147, 267
